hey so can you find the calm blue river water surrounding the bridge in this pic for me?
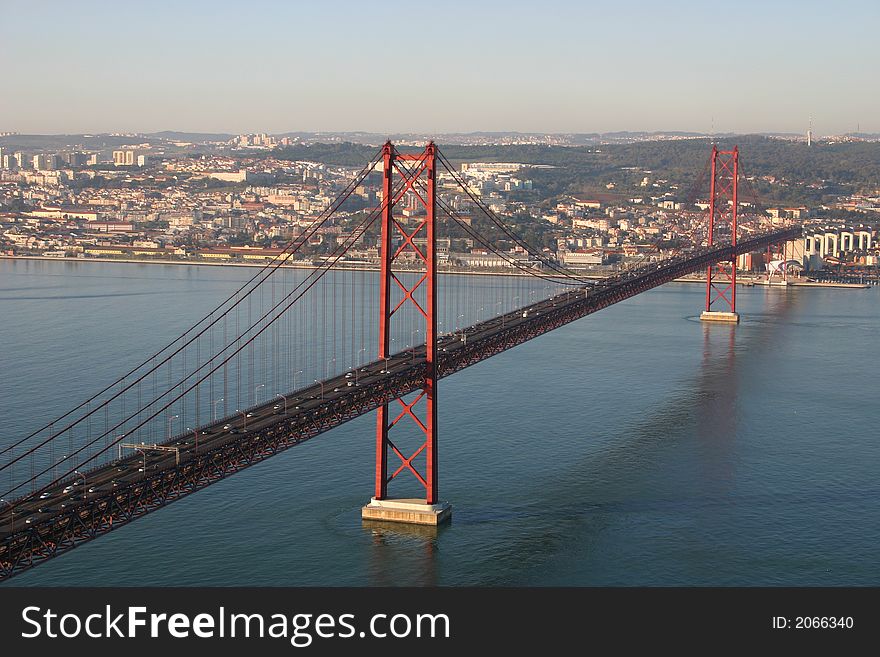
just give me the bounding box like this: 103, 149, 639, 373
0, 261, 880, 585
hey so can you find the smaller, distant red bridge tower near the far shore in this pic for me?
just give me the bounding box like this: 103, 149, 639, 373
700, 144, 739, 323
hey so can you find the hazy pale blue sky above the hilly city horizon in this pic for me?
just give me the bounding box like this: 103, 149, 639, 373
0, 0, 880, 134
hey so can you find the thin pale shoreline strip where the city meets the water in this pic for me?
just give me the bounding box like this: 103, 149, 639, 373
0, 255, 871, 289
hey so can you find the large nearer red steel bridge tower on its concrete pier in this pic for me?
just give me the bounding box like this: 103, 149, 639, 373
361, 141, 452, 525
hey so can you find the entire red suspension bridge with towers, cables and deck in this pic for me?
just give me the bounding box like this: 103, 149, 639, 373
0, 143, 802, 580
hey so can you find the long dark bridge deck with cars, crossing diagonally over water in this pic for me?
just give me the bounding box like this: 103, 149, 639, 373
0, 228, 801, 581
